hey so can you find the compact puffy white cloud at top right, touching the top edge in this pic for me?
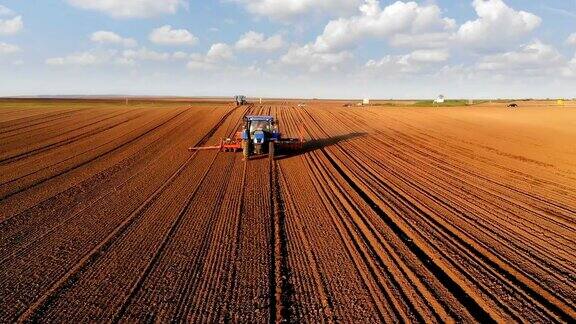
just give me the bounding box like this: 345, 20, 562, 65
456, 0, 542, 48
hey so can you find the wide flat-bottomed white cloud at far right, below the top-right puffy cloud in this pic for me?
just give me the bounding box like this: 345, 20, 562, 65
477, 40, 566, 73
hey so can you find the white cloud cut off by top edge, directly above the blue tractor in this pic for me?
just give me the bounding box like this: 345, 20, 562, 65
232, 0, 362, 20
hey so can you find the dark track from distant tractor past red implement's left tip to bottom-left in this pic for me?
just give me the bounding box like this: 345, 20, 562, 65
18, 104, 240, 322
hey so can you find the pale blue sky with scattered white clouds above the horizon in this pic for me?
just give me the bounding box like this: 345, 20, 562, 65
0, 0, 576, 99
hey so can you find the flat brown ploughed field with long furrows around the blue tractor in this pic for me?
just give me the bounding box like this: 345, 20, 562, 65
0, 100, 576, 323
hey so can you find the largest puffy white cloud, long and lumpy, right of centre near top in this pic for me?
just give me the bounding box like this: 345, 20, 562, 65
314, 0, 455, 51
